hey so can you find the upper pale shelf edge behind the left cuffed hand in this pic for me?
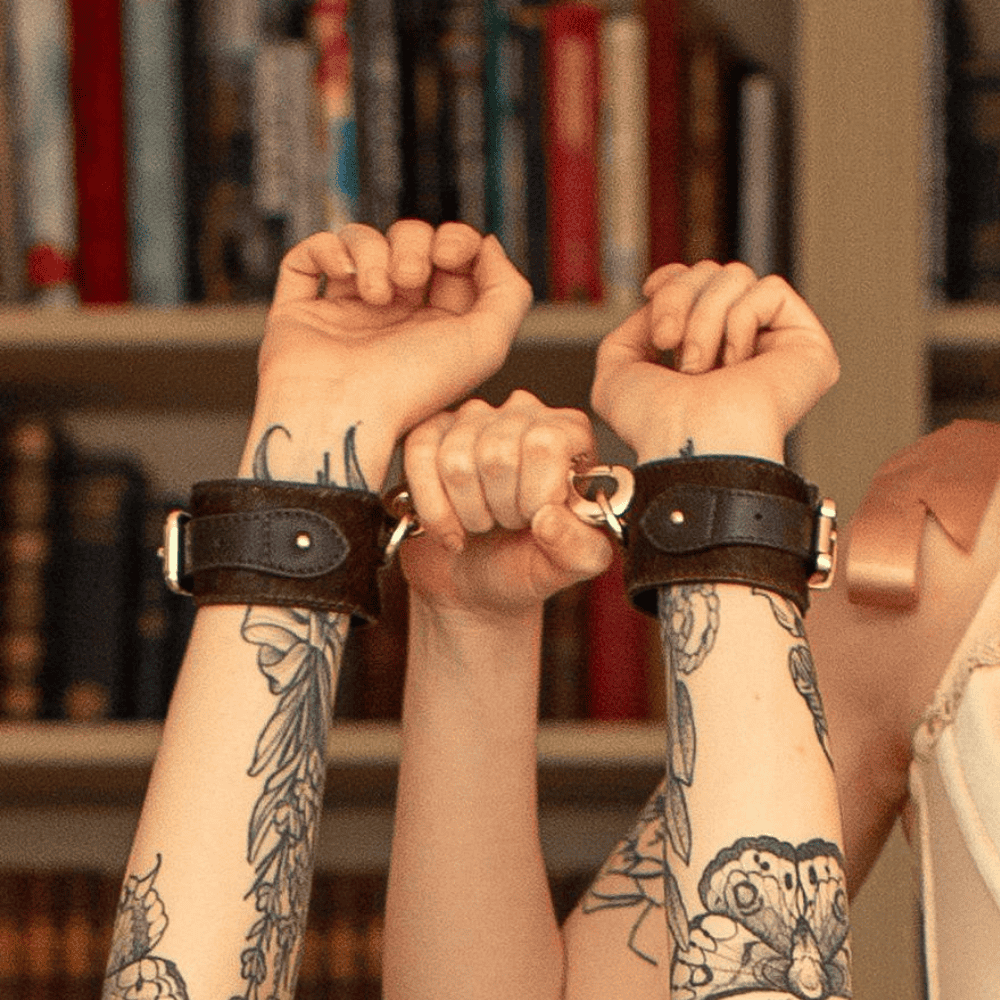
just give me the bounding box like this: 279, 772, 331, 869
0, 303, 630, 351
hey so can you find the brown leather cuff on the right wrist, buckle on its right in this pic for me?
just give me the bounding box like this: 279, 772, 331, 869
625, 455, 836, 615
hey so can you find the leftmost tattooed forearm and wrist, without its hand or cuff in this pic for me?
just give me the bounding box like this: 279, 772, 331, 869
107, 411, 378, 1000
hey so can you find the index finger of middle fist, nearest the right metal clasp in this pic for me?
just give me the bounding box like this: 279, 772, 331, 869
518, 409, 597, 521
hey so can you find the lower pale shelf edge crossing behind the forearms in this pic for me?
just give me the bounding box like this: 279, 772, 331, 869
0, 721, 665, 769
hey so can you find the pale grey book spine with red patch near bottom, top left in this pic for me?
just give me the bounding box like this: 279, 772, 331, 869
8, 0, 78, 305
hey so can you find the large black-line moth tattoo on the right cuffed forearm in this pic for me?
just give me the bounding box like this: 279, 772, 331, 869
671, 837, 853, 1000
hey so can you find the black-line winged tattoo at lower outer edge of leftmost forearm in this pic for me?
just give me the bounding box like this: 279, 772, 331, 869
101, 855, 188, 1000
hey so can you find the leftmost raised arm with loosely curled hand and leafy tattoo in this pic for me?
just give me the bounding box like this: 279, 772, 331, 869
104, 221, 530, 1000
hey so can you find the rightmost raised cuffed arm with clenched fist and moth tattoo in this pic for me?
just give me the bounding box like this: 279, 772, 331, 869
565, 263, 851, 1000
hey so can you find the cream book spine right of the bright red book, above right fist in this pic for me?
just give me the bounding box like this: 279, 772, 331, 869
600, 13, 649, 307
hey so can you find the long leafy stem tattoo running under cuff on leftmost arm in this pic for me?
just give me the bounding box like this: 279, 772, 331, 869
232, 424, 367, 1000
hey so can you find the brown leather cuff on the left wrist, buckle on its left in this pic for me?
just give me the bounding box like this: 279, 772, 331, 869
165, 479, 389, 621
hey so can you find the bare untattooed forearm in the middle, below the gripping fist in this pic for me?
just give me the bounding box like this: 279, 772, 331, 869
384, 596, 563, 1000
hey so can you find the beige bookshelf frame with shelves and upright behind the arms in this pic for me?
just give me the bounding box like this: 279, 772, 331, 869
0, 0, 972, 1000
